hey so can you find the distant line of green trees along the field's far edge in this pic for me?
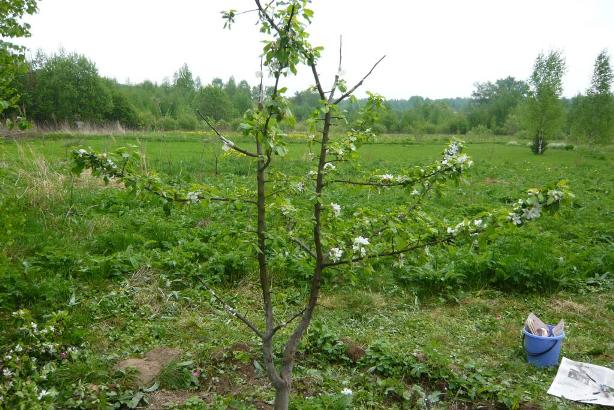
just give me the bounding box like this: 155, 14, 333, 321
4, 51, 614, 147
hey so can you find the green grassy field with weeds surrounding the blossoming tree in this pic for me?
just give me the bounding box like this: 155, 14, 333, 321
0, 133, 614, 409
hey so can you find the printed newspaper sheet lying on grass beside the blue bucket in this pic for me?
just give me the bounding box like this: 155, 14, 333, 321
548, 357, 614, 407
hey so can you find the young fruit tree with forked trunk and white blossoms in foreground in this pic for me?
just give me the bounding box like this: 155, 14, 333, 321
73, 0, 571, 409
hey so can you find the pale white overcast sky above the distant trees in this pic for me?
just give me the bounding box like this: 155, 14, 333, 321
18, 0, 614, 98
